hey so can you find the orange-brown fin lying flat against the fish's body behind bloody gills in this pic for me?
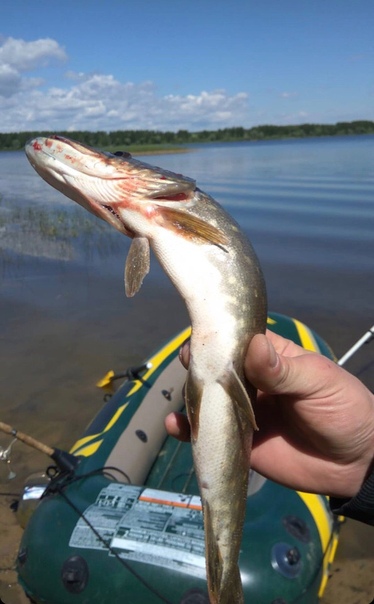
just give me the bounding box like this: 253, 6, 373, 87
155, 206, 228, 252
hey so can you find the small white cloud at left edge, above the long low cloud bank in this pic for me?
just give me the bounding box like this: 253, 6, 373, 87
0, 38, 67, 98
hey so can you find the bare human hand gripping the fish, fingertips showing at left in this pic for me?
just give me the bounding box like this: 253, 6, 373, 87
165, 331, 374, 498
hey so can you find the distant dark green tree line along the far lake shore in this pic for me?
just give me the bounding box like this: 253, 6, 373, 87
0, 120, 374, 151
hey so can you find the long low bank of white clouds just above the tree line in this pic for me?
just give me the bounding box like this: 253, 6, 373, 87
0, 54, 248, 132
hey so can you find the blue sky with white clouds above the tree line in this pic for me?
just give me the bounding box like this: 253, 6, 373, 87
0, 0, 374, 132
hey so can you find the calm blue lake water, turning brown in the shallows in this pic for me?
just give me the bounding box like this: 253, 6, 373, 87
0, 136, 374, 600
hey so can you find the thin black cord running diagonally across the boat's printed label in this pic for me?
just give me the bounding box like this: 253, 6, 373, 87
50, 467, 173, 604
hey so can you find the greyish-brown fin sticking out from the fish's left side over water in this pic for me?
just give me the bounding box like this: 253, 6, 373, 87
125, 237, 150, 298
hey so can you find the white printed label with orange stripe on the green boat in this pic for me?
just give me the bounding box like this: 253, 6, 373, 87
69, 483, 205, 578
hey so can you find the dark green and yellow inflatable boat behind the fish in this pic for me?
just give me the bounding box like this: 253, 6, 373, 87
17, 314, 338, 604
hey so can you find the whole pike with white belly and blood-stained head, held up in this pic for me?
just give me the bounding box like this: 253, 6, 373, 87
25, 135, 267, 604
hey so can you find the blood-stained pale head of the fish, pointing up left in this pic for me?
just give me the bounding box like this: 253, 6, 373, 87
25, 135, 196, 237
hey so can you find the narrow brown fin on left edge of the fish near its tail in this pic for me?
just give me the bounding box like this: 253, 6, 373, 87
204, 501, 223, 604
